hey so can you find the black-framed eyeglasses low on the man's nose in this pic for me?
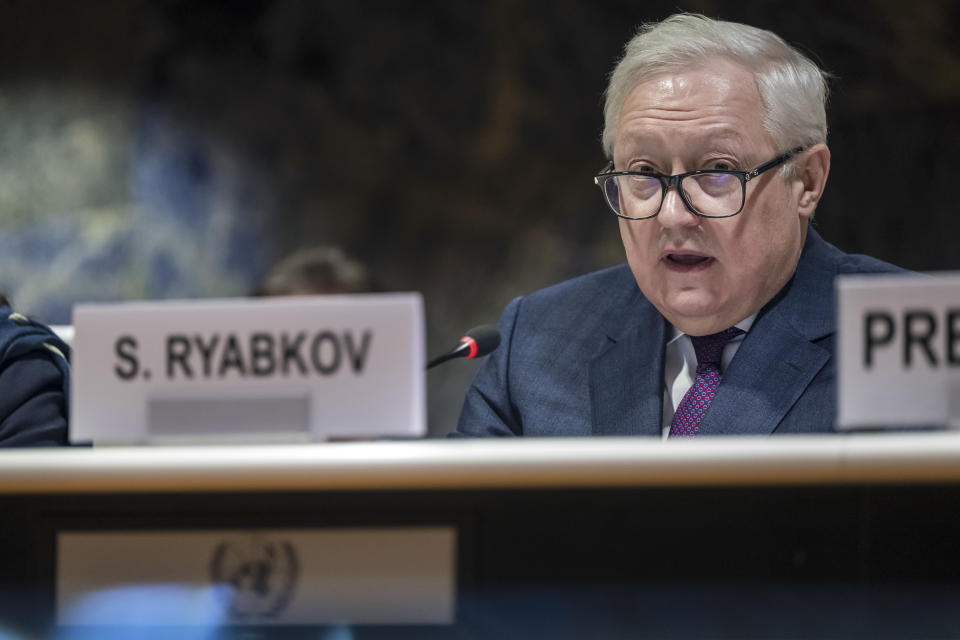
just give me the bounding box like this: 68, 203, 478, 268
593, 147, 804, 220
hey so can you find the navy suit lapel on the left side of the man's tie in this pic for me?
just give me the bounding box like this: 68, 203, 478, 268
590, 291, 667, 436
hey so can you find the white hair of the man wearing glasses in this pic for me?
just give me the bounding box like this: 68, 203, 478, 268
603, 13, 829, 158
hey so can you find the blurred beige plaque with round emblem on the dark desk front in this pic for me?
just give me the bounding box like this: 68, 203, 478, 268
56, 527, 456, 627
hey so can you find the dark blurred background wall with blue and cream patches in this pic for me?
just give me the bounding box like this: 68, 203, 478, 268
0, 0, 960, 435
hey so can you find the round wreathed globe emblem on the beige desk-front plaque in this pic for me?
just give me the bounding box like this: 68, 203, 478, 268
210, 535, 299, 620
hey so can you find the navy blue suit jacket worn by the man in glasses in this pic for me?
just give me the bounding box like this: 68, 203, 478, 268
453, 229, 899, 436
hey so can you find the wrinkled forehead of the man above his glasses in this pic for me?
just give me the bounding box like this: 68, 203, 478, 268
614, 61, 768, 150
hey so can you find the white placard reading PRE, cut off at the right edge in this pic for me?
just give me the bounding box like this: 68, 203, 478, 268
837, 273, 960, 429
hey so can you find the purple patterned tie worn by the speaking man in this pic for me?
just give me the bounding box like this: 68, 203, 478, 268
670, 327, 743, 438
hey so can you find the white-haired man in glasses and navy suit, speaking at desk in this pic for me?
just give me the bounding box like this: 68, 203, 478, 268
456, 14, 895, 437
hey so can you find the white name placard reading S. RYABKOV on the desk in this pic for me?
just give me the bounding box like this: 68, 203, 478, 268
70, 293, 426, 443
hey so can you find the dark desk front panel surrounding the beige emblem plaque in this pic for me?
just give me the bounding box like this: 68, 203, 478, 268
0, 482, 960, 638
